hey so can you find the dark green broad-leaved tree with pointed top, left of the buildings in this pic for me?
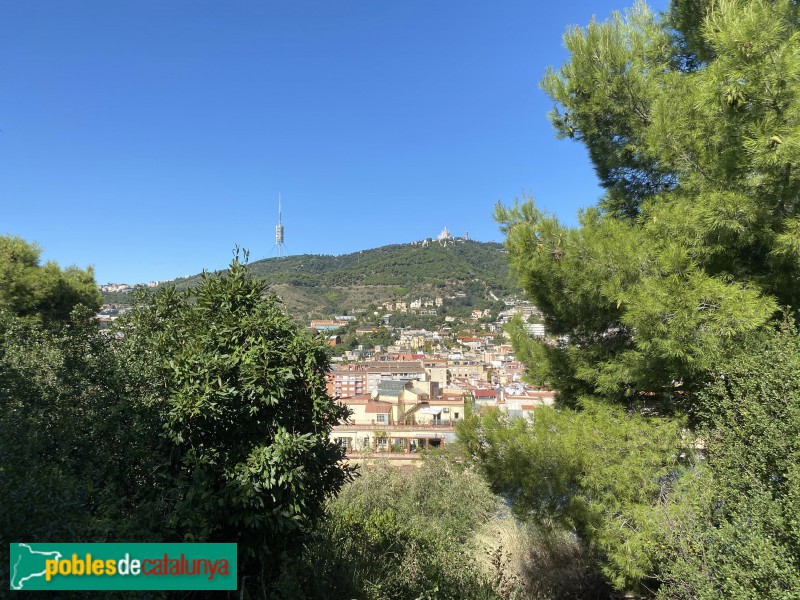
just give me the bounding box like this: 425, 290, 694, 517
121, 254, 350, 576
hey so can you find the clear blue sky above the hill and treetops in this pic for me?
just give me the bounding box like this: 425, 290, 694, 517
0, 0, 664, 283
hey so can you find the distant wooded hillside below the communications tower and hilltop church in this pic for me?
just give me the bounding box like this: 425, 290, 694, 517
104, 241, 519, 318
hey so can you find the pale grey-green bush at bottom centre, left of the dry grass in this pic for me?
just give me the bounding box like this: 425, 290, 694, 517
273, 455, 500, 600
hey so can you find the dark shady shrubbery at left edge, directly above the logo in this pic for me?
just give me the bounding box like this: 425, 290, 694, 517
0, 309, 166, 574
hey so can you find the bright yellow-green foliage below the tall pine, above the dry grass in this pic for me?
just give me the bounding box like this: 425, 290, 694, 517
458, 399, 691, 593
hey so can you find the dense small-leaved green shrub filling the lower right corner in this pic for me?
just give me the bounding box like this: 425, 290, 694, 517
661, 325, 800, 600
